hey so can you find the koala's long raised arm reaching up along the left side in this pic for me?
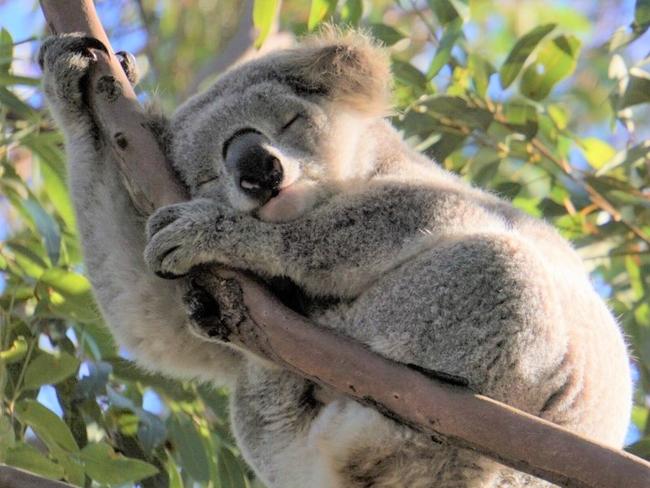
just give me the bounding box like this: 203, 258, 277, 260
40, 35, 240, 384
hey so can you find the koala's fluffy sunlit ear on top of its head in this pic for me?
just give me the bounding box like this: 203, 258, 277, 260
278, 26, 391, 115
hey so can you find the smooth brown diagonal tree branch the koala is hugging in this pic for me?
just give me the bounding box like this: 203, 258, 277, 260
31, 0, 650, 488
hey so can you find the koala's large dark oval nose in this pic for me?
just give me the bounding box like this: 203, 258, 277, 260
224, 129, 284, 205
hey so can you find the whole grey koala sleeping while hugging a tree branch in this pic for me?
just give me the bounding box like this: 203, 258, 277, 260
40, 29, 631, 488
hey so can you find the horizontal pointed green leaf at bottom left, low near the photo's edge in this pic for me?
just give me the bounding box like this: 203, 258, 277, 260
79, 442, 158, 485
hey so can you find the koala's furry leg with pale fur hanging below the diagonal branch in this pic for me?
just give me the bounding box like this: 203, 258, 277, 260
231, 363, 498, 488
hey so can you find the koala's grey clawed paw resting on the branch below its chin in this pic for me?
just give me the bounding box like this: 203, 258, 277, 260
144, 200, 219, 279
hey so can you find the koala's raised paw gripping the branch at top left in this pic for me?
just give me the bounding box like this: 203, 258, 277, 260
38, 33, 108, 108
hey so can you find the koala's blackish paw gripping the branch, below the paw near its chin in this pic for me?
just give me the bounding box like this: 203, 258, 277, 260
183, 269, 246, 342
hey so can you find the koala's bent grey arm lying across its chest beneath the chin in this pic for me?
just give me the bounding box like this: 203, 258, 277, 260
145, 177, 499, 296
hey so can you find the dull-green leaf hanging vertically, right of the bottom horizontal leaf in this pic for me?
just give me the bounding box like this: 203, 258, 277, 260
167, 413, 210, 481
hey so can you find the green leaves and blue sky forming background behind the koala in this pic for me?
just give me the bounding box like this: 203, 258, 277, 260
0, 0, 650, 487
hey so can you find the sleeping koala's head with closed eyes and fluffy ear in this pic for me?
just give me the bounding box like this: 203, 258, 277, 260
172, 29, 390, 221
